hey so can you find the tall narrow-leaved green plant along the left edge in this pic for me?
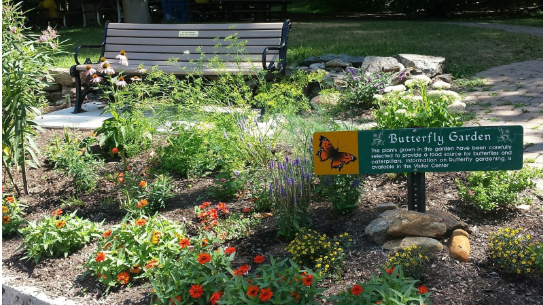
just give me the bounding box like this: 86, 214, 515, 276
2, 0, 65, 194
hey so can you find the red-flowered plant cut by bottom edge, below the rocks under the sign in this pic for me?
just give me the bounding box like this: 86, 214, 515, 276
330, 265, 431, 305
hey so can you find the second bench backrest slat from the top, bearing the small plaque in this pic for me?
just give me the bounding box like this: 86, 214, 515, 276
107, 29, 281, 40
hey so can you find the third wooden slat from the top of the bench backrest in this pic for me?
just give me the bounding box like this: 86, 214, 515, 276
106, 37, 281, 46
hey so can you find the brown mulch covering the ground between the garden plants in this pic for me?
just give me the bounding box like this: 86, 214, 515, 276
2, 125, 543, 305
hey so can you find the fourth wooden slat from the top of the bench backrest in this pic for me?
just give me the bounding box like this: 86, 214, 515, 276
105, 44, 279, 58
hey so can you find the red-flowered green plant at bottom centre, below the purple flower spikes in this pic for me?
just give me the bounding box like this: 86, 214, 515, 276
221, 256, 324, 304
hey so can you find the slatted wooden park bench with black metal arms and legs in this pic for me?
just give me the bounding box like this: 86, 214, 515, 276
70, 20, 291, 113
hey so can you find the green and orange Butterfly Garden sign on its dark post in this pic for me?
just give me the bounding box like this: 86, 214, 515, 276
313, 126, 523, 213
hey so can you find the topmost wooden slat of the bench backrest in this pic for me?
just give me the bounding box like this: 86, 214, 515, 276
108, 23, 283, 31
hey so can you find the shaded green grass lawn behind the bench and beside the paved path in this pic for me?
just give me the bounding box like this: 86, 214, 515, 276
53, 21, 543, 76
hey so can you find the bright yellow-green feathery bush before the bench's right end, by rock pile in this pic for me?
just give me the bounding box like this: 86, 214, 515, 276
254, 70, 324, 115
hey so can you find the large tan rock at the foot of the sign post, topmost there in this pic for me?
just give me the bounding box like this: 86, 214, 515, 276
387, 210, 447, 238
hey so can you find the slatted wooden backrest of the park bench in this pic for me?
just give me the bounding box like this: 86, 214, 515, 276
103, 20, 290, 72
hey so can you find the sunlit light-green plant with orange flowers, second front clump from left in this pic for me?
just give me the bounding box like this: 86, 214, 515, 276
85, 216, 201, 290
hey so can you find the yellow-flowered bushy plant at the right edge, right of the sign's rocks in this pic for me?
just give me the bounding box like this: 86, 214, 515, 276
488, 228, 541, 274
